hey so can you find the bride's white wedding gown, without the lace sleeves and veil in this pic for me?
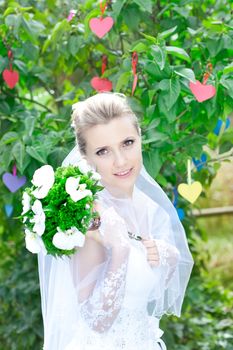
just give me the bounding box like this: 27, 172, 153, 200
66, 239, 166, 350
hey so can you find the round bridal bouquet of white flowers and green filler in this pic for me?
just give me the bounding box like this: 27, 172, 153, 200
21, 159, 104, 256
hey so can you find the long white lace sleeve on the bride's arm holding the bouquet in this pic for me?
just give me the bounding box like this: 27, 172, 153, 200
77, 208, 130, 333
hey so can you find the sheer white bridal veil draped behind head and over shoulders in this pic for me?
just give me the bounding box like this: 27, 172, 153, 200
38, 129, 193, 350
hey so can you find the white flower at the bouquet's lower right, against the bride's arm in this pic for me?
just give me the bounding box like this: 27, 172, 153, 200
53, 226, 85, 250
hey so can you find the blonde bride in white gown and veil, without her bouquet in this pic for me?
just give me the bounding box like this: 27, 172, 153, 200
38, 92, 193, 350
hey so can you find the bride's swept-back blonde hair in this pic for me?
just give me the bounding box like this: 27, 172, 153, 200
72, 92, 141, 155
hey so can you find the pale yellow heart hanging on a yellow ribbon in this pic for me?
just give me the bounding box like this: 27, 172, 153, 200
177, 159, 202, 204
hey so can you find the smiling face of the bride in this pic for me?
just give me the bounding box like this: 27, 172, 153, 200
84, 116, 142, 197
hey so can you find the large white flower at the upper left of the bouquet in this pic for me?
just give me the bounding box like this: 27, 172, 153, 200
32, 165, 55, 199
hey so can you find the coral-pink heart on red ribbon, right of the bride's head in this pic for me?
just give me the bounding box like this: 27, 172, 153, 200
189, 63, 216, 102
